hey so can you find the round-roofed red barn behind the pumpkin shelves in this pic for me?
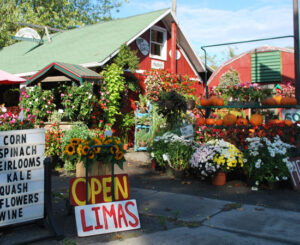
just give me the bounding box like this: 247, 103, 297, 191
207, 46, 295, 88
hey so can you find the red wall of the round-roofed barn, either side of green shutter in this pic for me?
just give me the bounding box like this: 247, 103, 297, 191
208, 51, 295, 90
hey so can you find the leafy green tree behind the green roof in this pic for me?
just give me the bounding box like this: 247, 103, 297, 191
0, 0, 127, 48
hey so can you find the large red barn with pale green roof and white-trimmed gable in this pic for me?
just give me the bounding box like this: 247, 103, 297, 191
0, 9, 210, 98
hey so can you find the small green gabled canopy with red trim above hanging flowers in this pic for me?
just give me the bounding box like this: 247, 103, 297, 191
26, 62, 103, 85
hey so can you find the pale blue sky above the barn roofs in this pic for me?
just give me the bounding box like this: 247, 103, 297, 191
113, 0, 293, 64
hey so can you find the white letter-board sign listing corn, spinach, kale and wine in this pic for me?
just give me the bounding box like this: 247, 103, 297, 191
0, 129, 45, 227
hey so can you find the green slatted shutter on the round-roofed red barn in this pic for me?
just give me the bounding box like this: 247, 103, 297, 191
251, 51, 281, 83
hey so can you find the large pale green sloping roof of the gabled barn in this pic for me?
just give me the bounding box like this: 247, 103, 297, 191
0, 9, 168, 74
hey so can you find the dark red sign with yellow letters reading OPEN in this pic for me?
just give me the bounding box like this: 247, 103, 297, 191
70, 174, 130, 206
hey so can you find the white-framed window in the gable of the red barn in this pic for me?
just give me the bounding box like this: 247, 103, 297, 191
150, 26, 167, 60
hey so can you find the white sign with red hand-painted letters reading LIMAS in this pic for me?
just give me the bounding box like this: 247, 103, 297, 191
75, 199, 141, 237
